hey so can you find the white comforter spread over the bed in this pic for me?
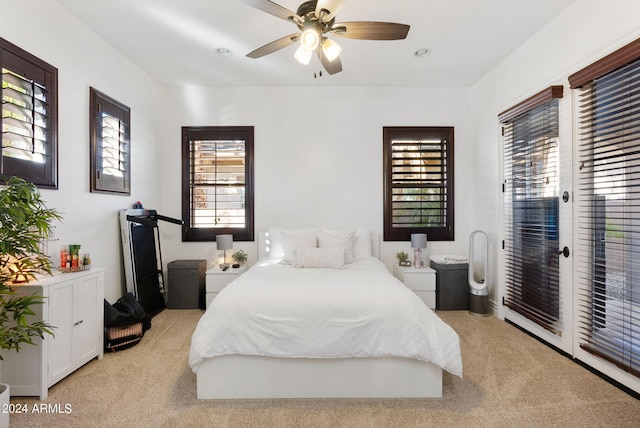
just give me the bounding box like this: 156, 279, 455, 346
189, 257, 462, 376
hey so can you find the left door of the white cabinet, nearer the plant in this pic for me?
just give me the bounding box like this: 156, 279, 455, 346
48, 281, 74, 385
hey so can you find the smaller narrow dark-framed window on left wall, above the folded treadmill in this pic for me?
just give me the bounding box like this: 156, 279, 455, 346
89, 88, 131, 195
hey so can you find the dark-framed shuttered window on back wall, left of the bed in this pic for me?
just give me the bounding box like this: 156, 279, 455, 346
182, 126, 253, 241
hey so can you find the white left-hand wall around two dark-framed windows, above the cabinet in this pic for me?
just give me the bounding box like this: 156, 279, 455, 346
0, 0, 162, 302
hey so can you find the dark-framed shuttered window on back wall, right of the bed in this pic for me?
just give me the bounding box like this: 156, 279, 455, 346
383, 127, 454, 241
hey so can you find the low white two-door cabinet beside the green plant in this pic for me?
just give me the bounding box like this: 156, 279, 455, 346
1, 268, 104, 400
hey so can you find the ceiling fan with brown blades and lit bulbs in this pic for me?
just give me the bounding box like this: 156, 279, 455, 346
243, 0, 409, 74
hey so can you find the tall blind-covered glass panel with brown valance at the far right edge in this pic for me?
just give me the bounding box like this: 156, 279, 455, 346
569, 39, 640, 377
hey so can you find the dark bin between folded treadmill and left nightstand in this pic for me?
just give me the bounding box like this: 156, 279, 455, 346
167, 260, 207, 309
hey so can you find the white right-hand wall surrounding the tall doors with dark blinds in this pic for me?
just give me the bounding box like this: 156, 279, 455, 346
470, 0, 640, 391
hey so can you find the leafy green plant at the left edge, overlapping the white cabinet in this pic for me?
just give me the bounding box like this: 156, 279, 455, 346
0, 177, 61, 408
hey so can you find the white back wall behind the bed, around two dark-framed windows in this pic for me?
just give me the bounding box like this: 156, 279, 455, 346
159, 87, 474, 266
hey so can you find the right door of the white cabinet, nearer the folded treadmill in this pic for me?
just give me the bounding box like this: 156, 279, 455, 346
71, 275, 103, 367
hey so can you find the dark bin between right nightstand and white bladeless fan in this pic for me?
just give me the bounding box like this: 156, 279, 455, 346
430, 256, 469, 311
